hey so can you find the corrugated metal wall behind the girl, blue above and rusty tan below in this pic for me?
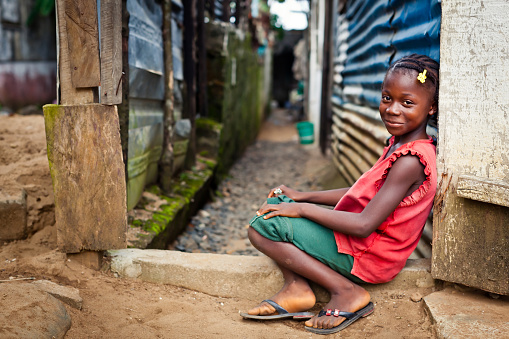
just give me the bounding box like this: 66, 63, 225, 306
331, 0, 441, 257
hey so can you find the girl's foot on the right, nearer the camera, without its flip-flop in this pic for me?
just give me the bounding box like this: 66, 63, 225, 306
305, 285, 371, 329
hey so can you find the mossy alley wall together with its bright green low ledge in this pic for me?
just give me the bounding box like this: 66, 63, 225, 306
127, 22, 270, 249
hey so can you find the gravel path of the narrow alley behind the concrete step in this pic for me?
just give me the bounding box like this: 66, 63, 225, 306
168, 109, 332, 255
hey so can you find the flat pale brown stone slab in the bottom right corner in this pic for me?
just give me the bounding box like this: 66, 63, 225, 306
424, 288, 509, 338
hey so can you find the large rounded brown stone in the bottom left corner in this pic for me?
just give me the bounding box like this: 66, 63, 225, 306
0, 282, 71, 339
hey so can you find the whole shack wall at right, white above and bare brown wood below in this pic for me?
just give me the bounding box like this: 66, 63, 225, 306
432, 0, 509, 294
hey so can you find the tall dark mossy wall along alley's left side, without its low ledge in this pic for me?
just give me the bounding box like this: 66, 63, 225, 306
205, 22, 269, 177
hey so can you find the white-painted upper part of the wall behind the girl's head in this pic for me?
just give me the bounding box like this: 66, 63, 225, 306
438, 0, 509, 183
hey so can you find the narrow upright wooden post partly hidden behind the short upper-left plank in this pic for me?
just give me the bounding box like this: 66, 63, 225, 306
56, 0, 94, 105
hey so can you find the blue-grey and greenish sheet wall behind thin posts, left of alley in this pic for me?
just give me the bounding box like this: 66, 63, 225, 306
127, 0, 184, 209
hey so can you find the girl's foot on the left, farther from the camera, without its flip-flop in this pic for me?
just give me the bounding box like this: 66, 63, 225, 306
247, 281, 316, 315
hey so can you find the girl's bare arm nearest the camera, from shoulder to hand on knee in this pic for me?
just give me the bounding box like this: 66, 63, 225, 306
257, 156, 423, 237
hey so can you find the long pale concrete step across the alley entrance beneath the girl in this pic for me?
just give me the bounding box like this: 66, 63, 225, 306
108, 249, 435, 302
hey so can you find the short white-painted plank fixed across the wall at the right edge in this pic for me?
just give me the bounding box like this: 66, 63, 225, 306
456, 175, 509, 207
